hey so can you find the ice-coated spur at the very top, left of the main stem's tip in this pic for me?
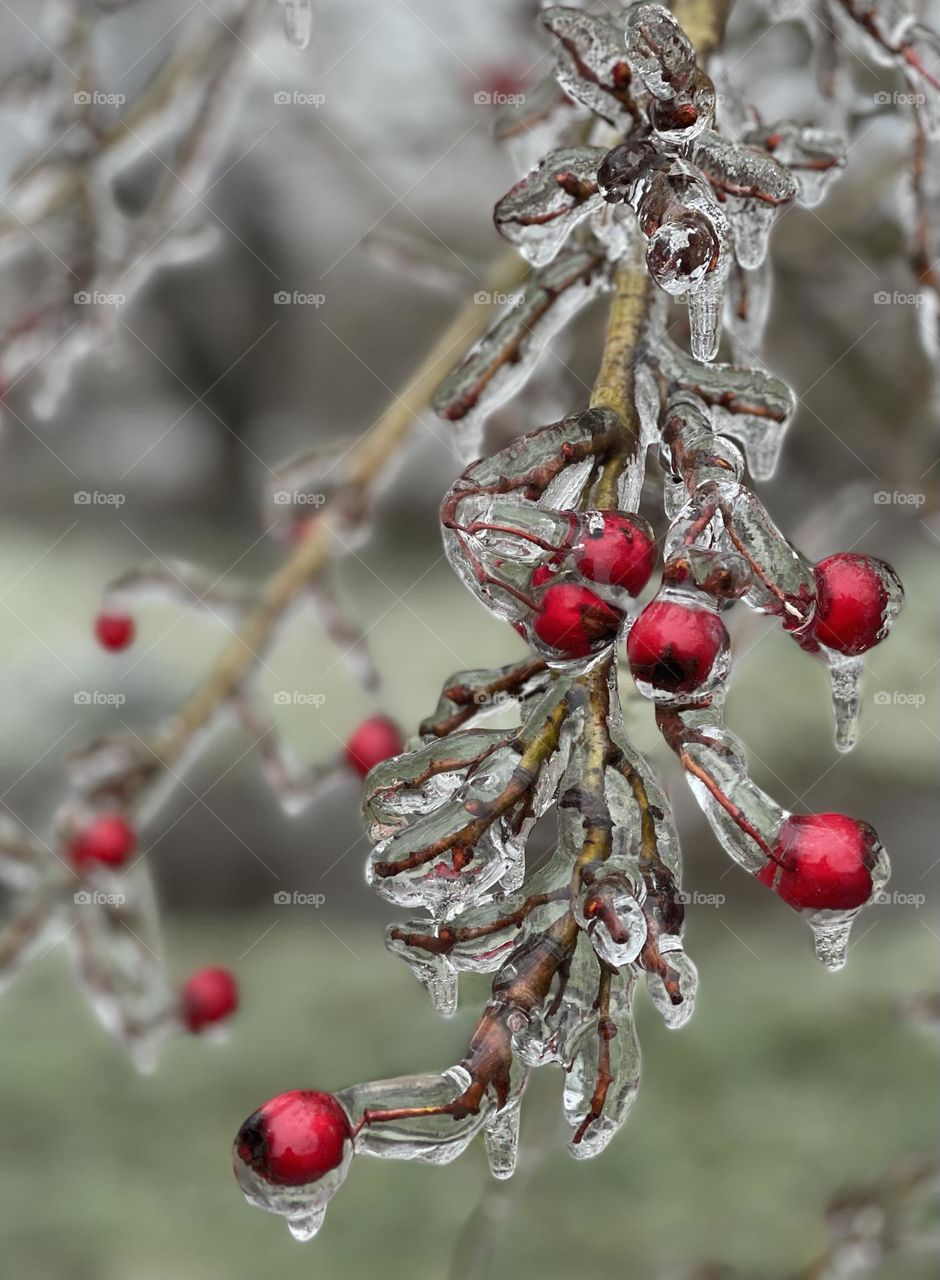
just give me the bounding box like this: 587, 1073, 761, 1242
542, 5, 645, 133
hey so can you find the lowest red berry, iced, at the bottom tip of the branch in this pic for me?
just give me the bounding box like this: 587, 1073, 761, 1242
236, 1089, 352, 1187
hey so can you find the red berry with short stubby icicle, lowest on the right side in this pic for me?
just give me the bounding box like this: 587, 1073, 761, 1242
757, 813, 879, 911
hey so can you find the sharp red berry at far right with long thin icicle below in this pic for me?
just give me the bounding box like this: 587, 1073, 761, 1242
812, 552, 904, 654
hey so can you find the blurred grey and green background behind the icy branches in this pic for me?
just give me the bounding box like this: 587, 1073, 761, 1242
0, 0, 940, 1280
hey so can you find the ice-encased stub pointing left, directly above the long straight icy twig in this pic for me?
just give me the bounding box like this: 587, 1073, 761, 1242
493, 146, 606, 266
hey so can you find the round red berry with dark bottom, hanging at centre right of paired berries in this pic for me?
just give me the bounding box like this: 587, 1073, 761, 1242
626, 600, 729, 694
